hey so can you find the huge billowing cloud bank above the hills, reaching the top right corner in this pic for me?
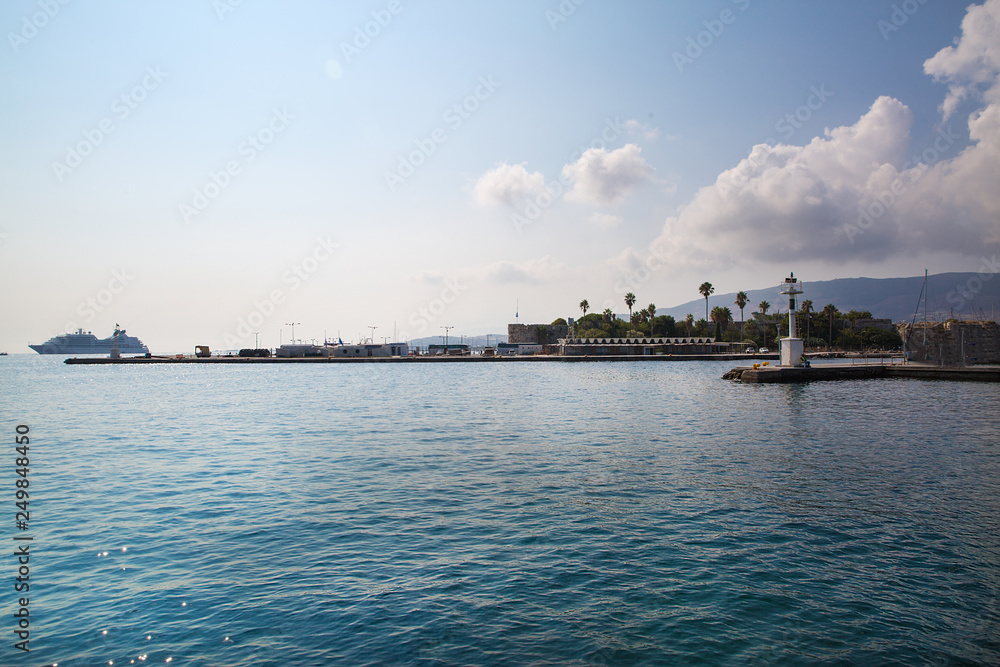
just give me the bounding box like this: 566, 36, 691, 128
636, 0, 1000, 274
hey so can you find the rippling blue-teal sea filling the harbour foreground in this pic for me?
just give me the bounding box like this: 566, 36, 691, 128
0, 354, 1000, 667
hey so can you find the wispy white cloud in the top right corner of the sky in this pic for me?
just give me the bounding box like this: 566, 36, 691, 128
924, 0, 1000, 120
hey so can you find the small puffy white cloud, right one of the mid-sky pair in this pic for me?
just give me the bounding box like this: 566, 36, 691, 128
562, 144, 655, 205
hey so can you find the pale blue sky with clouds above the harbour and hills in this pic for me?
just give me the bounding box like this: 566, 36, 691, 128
0, 0, 1000, 353
